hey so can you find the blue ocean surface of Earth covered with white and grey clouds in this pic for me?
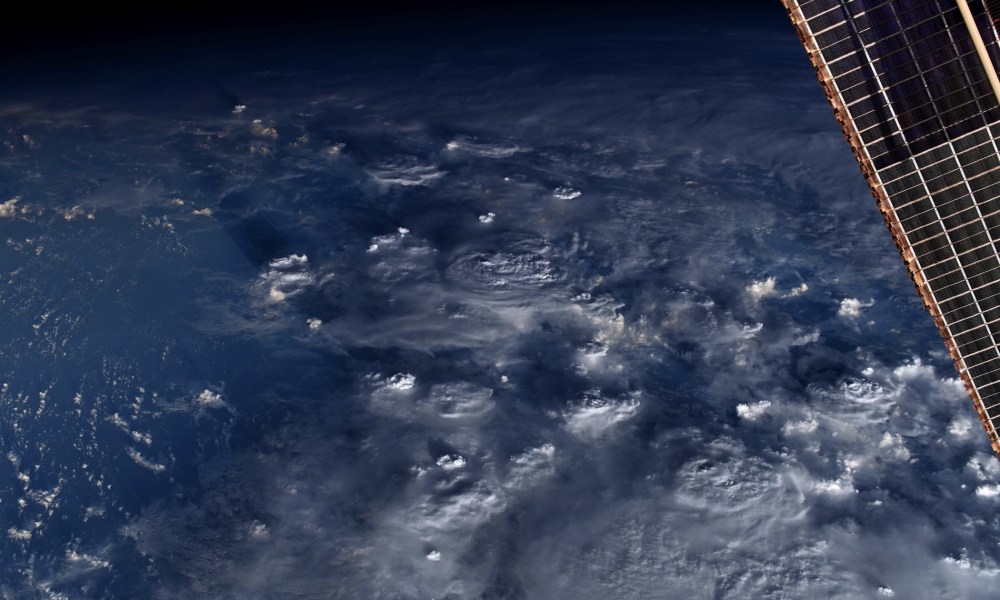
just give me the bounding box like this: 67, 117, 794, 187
0, 5, 1000, 600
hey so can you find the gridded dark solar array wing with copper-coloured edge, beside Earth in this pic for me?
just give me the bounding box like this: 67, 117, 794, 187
782, 0, 1000, 456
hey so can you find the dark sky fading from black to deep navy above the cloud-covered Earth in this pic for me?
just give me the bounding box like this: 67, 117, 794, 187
0, 0, 794, 99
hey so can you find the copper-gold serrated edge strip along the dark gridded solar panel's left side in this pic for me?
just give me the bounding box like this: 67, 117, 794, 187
781, 0, 1000, 458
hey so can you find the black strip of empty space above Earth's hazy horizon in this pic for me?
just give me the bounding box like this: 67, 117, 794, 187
0, 0, 791, 72
